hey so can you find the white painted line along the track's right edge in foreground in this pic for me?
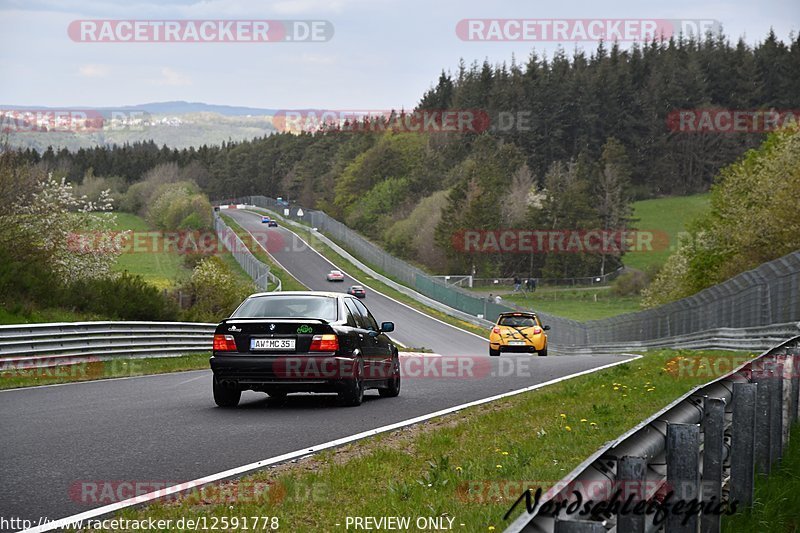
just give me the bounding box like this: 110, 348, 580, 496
20, 354, 643, 533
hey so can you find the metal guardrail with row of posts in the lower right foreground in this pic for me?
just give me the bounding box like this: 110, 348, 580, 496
506, 337, 800, 533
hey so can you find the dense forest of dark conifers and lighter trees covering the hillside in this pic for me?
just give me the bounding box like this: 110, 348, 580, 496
12, 28, 800, 277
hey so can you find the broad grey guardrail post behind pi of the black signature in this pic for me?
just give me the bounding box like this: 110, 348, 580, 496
665, 424, 700, 533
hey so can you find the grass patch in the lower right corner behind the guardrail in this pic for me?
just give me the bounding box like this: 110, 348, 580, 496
722, 424, 800, 533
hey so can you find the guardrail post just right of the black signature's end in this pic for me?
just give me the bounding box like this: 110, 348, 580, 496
730, 383, 758, 506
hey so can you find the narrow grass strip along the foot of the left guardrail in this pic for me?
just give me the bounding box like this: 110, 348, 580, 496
0, 353, 211, 389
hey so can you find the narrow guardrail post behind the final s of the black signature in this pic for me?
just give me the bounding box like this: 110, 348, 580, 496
700, 397, 725, 533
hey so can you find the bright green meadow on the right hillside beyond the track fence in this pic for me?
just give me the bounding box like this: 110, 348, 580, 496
623, 193, 711, 270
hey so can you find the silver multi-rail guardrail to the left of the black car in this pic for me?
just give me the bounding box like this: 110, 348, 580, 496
0, 322, 216, 368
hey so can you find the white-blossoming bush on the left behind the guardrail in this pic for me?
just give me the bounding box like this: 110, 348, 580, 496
11, 174, 125, 284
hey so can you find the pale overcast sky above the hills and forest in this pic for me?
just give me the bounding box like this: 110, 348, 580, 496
0, 0, 800, 109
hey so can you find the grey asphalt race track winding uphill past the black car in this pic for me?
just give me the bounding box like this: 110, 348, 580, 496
0, 211, 632, 520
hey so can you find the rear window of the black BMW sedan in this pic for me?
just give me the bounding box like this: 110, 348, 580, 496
231, 295, 337, 320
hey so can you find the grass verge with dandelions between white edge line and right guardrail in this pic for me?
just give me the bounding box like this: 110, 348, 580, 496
89, 350, 756, 532
